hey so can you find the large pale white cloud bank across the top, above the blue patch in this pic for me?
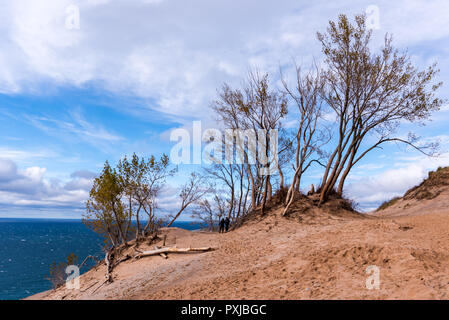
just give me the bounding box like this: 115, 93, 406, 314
0, 0, 449, 122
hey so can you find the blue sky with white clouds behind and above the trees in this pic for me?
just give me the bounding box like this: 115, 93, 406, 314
0, 0, 449, 218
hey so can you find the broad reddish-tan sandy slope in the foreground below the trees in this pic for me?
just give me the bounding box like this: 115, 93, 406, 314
29, 189, 449, 299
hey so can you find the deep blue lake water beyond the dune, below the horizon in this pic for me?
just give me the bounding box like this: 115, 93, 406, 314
0, 218, 200, 300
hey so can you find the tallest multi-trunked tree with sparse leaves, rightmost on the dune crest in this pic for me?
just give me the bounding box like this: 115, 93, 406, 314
318, 15, 442, 204
